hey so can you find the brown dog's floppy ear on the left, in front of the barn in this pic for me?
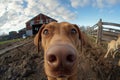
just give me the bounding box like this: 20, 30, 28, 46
34, 24, 45, 52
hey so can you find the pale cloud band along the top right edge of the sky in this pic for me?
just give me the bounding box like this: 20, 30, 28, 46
70, 0, 120, 8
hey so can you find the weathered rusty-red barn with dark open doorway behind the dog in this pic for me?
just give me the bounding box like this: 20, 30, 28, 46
26, 13, 57, 36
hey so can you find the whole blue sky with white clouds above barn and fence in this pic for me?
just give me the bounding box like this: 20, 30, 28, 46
0, 0, 120, 35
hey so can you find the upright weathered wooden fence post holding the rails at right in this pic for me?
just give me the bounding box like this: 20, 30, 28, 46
96, 19, 103, 44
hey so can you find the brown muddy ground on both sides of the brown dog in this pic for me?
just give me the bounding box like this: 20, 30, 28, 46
0, 39, 120, 80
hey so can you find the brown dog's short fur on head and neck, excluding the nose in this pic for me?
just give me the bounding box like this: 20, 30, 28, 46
34, 22, 84, 80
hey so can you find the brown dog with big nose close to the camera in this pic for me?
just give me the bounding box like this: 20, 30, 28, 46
34, 22, 83, 80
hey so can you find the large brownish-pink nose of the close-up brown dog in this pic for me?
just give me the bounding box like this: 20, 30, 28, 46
46, 45, 77, 68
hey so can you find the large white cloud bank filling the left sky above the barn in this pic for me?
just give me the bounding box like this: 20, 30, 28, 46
0, 0, 76, 34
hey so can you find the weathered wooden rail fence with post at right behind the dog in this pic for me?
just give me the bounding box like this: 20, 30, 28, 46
90, 19, 120, 44
